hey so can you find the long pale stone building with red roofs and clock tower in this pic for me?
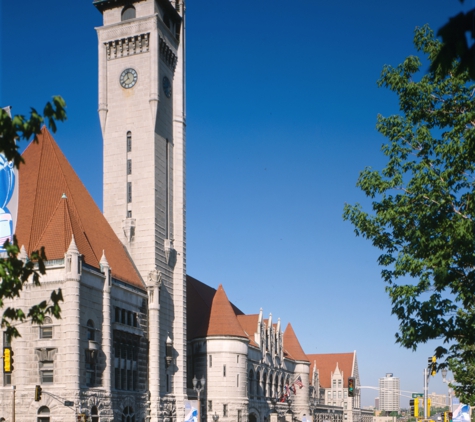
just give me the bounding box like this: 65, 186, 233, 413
0, 0, 368, 422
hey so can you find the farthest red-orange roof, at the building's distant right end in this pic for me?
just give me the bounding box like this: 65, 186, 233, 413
307, 352, 355, 388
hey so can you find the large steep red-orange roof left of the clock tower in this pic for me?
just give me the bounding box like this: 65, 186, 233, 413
16, 127, 145, 289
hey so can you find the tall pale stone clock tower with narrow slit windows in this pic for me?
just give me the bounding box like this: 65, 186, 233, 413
94, 0, 186, 422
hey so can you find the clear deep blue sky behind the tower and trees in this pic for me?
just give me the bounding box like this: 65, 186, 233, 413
0, 0, 475, 405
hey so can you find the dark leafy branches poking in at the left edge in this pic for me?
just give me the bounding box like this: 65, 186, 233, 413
0, 96, 66, 337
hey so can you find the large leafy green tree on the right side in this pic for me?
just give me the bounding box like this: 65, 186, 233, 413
344, 26, 475, 404
